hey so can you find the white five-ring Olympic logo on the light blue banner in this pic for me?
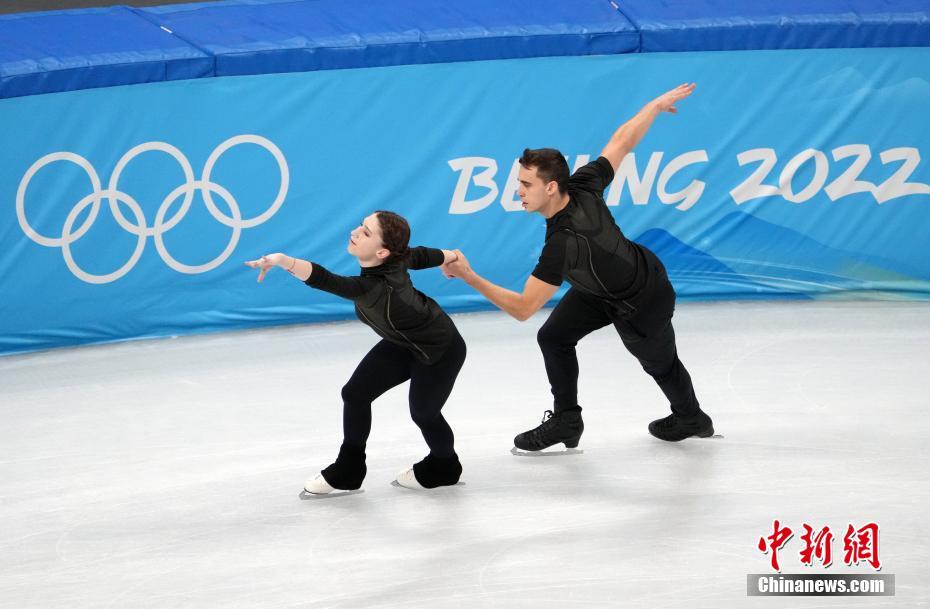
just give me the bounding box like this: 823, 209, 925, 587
16, 135, 290, 284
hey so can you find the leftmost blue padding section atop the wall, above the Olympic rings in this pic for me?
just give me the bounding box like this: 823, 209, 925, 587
0, 6, 213, 98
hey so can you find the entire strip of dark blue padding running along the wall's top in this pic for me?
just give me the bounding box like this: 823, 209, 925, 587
0, 0, 930, 98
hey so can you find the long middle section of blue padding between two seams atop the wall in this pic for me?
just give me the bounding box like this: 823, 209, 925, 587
139, 0, 639, 76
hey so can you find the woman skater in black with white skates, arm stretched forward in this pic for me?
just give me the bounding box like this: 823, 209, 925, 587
246, 211, 465, 495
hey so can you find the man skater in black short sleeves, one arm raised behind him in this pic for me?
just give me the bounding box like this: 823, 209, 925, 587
443, 83, 714, 451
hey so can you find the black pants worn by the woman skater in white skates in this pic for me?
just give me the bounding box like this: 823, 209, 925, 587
342, 334, 465, 457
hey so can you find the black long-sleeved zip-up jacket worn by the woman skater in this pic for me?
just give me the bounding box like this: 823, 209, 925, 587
304, 247, 458, 364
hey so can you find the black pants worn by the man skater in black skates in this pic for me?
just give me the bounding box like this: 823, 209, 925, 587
537, 264, 700, 416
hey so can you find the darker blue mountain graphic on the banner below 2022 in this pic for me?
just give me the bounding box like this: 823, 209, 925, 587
635, 212, 915, 298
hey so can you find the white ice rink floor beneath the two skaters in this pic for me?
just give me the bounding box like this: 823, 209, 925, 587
0, 301, 930, 609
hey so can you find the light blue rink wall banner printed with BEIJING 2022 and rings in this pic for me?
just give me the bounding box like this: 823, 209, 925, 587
0, 48, 930, 352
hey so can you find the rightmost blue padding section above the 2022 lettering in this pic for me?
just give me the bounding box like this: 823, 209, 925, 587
614, 0, 930, 53
